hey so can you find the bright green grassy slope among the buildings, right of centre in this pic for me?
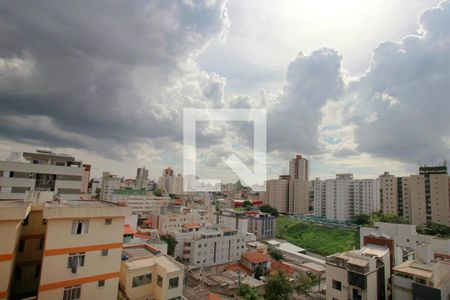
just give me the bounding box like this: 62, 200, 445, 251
277, 216, 359, 256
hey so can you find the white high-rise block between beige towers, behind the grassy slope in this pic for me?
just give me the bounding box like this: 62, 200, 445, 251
313, 174, 380, 221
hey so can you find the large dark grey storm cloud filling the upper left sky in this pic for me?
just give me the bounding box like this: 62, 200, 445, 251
0, 1, 227, 155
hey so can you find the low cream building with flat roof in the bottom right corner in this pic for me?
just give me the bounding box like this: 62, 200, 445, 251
392, 259, 450, 300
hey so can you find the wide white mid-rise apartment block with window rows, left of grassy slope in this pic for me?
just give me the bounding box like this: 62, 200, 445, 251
172, 224, 256, 267
